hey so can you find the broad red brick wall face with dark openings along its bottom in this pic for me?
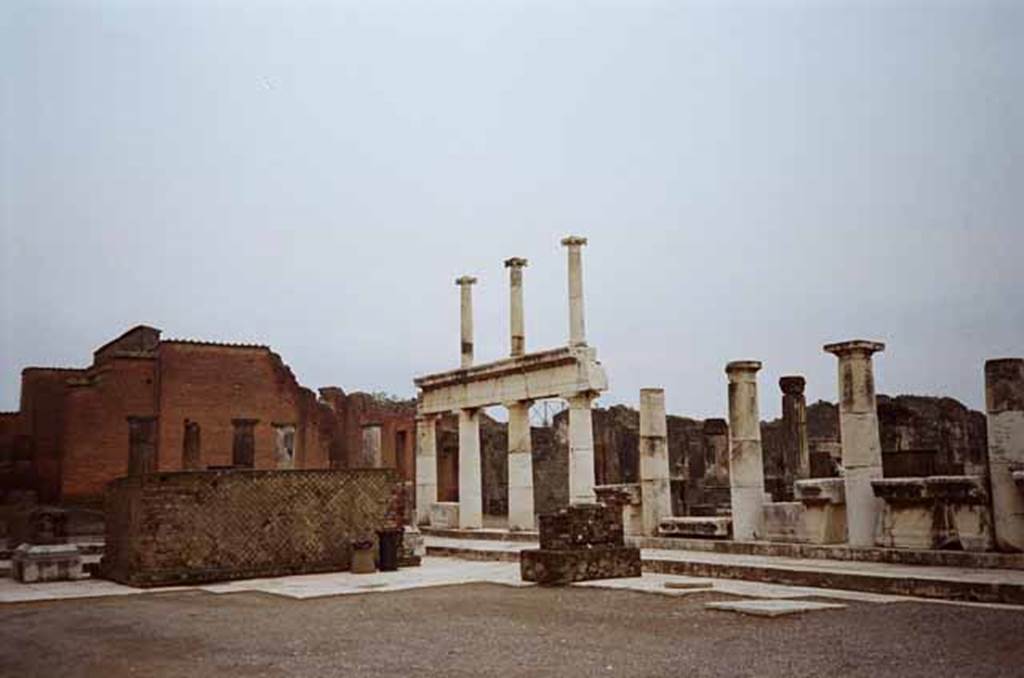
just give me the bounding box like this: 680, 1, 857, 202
159, 342, 326, 470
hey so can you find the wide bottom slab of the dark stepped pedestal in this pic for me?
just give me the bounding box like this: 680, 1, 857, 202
519, 546, 641, 586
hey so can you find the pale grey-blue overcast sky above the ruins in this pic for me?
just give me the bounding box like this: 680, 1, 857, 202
0, 0, 1024, 417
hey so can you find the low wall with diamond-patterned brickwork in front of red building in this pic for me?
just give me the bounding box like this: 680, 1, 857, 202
100, 469, 401, 587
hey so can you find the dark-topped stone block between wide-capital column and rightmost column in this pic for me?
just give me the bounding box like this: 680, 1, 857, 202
871, 475, 993, 551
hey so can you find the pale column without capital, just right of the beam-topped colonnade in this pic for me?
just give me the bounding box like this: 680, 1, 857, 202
640, 388, 672, 537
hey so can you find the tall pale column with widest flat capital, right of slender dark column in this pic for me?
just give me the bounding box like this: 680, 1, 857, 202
824, 340, 886, 546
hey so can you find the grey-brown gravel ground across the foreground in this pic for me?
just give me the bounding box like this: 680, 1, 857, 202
0, 585, 1024, 678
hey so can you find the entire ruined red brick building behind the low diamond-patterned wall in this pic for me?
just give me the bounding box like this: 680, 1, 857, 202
0, 326, 415, 503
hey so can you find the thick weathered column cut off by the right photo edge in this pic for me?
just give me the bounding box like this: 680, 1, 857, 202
985, 357, 1024, 551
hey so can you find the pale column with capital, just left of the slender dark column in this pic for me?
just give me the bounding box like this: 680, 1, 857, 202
725, 361, 765, 541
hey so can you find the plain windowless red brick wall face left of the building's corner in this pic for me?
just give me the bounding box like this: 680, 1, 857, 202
60, 357, 160, 502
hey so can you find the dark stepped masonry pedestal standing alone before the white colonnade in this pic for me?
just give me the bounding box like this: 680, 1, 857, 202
519, 504, 640, 586
